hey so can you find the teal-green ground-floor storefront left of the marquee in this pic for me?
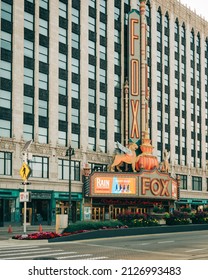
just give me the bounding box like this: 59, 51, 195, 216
0, 190, 82, 226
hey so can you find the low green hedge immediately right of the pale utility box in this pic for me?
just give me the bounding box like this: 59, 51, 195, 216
63, 220, 123, 233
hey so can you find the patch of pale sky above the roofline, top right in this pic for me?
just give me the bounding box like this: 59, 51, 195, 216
178, 0, 208, 21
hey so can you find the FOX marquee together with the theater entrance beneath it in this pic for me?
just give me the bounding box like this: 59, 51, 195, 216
83, 169, 179, 220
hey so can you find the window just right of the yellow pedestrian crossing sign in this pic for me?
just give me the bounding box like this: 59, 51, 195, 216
29, 156, 49, 178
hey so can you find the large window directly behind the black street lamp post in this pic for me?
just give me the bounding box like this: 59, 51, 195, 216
58, 159, 80, 181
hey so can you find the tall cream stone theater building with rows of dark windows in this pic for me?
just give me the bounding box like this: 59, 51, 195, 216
0, 0, 208, 226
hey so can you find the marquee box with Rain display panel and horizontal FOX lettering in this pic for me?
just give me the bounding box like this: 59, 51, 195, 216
90, 169, 178, 200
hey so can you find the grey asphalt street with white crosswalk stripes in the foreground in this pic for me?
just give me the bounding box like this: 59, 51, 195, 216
0, 230, 208, 260
